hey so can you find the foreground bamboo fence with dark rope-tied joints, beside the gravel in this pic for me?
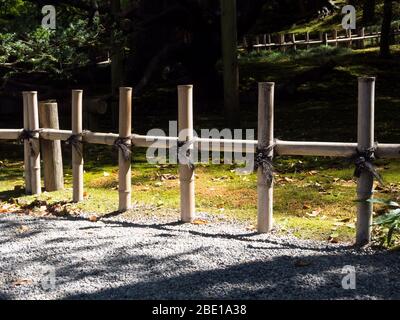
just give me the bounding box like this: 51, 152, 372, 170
0, 78, 400, 245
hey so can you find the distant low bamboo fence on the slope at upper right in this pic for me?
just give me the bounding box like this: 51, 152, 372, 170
239, 26, 400, 51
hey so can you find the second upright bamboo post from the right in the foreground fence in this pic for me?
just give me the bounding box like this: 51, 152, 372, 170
257, 82, 275, 233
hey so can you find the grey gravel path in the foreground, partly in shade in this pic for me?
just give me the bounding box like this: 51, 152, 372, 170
0, 215, 400, 299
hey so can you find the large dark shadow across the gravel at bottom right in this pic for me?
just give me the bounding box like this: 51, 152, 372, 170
61, 253, 400, 300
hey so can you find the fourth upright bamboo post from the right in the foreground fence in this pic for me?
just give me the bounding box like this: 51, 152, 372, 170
118, 87, 132, 212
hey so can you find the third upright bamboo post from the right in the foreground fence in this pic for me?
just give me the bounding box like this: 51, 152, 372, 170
178, 85, 195, 223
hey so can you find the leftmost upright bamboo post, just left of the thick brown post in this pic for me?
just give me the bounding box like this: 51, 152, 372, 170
26, 91, 42, 195
